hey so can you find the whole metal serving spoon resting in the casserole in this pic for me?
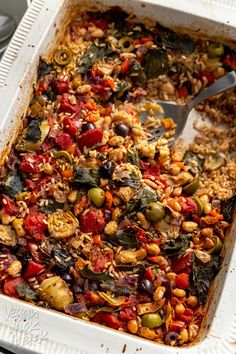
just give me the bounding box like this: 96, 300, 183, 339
141, 71, 236, 143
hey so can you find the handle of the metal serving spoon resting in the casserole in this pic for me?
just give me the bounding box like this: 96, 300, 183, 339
187, 71, 236, 110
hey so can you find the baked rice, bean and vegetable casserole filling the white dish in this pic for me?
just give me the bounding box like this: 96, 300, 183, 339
0, 8, 236, 346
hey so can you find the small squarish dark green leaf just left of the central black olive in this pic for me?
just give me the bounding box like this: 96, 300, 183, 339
73, 167, 99, 187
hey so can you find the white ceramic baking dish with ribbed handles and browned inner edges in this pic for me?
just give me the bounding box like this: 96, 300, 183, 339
0, 0, 236, 354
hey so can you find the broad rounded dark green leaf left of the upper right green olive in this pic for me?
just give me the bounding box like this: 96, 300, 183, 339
144, 49, 169, 79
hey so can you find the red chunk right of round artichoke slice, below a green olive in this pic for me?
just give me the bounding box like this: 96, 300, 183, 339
80, 210, 105, 233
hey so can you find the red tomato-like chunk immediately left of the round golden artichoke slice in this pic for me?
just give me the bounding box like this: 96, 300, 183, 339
24, 214, 47, 240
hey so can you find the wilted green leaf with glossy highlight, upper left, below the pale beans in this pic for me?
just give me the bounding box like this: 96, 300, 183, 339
78, 44, 113, 74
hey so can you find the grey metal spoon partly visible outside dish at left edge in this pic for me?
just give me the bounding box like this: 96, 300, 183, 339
0, 14, 16, 53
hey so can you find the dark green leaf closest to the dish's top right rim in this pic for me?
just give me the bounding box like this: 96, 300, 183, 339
160, 27, 196, 54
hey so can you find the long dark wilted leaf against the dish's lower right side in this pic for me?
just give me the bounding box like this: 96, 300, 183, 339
192, 256, 220, 304
